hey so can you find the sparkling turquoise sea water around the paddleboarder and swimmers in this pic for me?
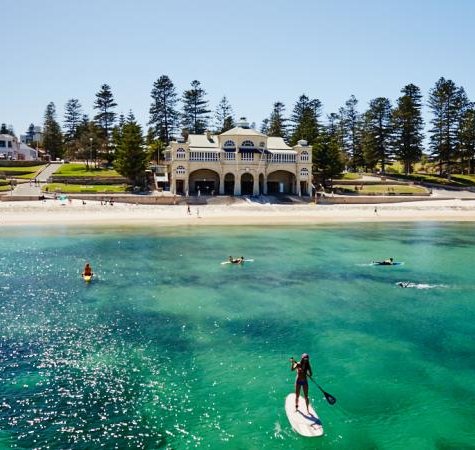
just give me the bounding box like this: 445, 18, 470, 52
0, 223, 475, 450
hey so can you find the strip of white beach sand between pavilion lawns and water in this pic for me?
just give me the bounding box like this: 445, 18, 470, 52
0, 200, 475, 227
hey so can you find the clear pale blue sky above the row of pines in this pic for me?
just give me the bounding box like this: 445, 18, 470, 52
0, 0, 475, 134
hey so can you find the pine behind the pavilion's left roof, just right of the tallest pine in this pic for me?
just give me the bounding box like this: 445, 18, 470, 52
182, 80, 210, 134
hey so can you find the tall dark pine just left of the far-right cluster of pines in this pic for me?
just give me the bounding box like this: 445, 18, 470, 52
392, 84, 424, 174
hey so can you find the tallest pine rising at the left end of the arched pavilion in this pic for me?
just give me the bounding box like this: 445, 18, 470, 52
148, 75, 179, 145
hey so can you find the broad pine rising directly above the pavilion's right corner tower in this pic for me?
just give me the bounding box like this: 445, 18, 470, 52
290, 94, 322, 145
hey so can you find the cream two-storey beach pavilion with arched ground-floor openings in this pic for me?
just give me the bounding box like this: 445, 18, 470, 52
165, 121, 312, 195
